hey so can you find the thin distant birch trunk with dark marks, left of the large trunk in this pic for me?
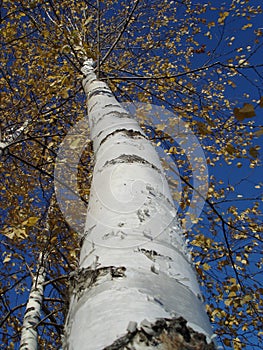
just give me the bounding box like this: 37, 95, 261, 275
19, 253, 46, 350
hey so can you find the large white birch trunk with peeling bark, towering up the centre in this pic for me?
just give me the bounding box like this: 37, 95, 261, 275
64, 60, 217, 350
